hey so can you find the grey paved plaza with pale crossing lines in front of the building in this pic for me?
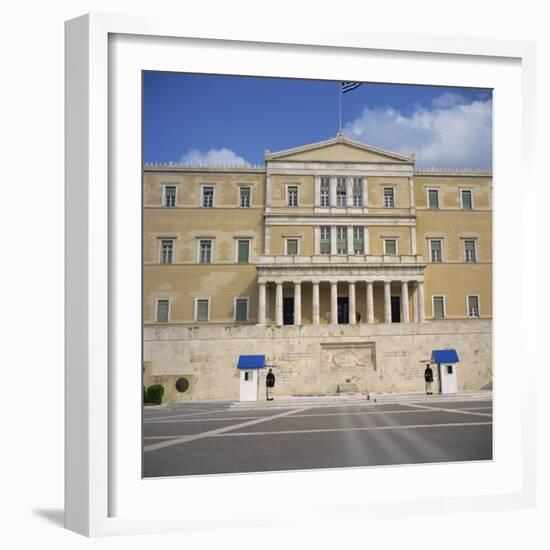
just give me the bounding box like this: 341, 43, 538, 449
143, 396, 493, 477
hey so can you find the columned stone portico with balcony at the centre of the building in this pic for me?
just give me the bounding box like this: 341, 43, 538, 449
258, 256, 425, 326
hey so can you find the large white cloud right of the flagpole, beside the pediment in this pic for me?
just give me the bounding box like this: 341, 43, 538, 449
344, 94, 492, 169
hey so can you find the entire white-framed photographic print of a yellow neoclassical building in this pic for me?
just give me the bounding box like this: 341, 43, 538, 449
66, 12, 534, 535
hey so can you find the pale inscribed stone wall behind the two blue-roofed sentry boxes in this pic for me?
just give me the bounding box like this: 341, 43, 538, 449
144, 319, 492, 402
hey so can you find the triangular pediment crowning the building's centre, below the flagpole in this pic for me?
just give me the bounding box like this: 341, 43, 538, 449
265, 134, 414, 164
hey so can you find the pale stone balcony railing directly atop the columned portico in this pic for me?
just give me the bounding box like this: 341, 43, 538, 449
258, 254, 424, 266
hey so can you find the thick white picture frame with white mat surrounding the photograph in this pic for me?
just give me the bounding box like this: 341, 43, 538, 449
65, 14, 536, 536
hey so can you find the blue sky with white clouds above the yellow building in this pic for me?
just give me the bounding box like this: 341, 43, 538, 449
143, 72, 492, 169
